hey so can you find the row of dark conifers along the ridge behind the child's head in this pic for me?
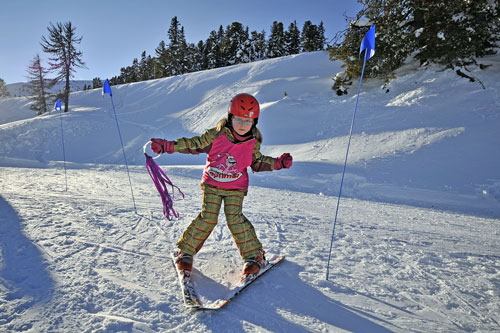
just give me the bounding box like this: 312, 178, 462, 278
107, 17, 336, 83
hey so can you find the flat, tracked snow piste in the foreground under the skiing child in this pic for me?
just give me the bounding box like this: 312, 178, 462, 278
0, 167, 500, 332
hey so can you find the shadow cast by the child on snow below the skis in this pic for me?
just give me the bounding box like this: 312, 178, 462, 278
195, 259, 391, 332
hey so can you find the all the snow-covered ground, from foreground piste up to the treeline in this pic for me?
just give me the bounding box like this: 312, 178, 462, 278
0, 52, 500, 332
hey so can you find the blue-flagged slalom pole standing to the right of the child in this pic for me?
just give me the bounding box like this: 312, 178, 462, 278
326, 25, 375, 280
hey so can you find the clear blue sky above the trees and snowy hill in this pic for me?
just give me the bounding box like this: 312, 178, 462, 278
0, 0, 361, 84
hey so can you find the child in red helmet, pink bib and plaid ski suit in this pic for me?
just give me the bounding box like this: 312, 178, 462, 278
151, 94, 292, 275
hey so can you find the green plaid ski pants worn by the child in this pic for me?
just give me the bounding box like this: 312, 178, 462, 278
177, 185, 262, 259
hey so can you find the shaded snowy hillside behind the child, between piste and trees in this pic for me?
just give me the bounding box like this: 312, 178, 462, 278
0, 52, 500, 217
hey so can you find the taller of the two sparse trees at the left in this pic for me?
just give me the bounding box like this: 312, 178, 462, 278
41, 22, 85, 112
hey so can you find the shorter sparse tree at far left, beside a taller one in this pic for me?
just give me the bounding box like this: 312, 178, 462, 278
27, 54, 55, 115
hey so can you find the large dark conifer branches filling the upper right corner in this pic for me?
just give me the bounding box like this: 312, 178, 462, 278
330, 0, 500, 87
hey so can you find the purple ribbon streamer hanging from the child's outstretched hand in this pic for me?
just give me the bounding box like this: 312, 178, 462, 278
144, 153, 184, 221
